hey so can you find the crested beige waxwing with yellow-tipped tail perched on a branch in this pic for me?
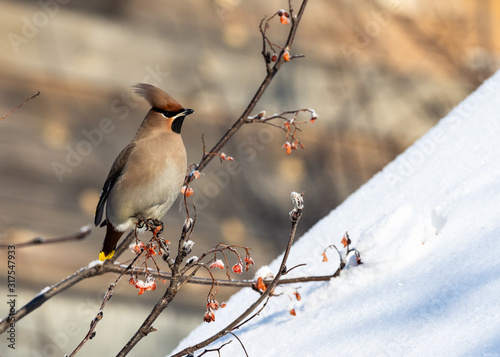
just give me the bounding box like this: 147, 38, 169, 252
94, 83, 194, 261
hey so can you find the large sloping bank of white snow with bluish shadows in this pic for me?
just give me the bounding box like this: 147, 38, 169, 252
173, 72, 500, 357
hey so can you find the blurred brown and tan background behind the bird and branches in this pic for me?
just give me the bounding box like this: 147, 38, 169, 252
0, 0, 500, 356
